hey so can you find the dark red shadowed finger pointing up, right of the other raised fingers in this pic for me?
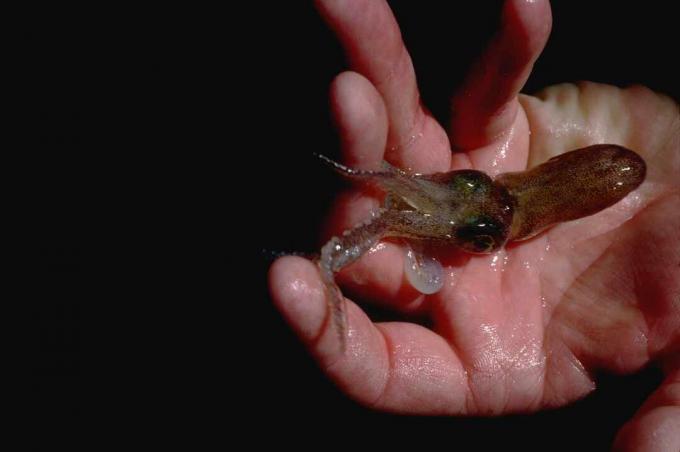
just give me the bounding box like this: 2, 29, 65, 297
451, 0, 552, 150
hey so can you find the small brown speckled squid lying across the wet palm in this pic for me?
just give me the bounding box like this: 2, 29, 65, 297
317, 144, 646, 347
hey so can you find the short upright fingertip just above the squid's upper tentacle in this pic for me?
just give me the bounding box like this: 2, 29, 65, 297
330, 71, 388, 169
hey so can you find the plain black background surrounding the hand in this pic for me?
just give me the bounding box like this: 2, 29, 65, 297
34, 1, 679, 450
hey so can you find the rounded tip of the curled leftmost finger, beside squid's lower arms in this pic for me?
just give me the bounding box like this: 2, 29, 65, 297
269, 256, 327, 342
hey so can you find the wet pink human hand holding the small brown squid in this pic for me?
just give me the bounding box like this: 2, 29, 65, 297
270, 0, 680, 451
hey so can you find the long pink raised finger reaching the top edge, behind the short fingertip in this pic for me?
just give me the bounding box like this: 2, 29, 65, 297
316, 0, 451, 172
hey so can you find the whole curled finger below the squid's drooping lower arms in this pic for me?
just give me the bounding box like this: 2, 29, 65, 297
269, 257, 469, 414
